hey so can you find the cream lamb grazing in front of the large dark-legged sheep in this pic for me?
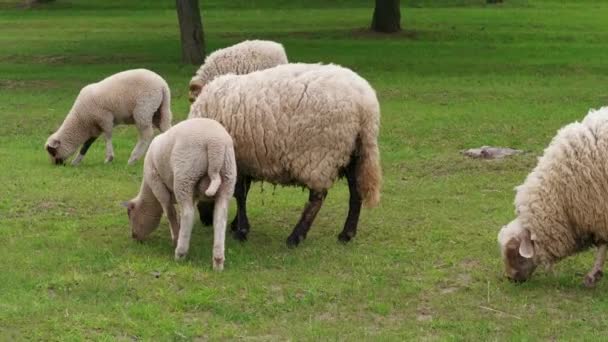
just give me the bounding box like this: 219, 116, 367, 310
123, 119, 236, 270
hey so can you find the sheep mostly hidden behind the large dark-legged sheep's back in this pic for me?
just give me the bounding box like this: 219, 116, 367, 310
188, 40, 287, 103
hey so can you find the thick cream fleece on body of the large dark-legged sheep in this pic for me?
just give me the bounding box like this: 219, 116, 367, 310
191, 64, 375, 190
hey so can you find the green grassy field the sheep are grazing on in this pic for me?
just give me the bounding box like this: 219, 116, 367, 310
0, 0, 608, 341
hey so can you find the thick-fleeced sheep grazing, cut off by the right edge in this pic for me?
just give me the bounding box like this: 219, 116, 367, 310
498, 107, 608, 287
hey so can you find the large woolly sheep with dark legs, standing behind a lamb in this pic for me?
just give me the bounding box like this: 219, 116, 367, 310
189, 64, 382, 247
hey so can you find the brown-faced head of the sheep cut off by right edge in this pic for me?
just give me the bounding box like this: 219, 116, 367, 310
498, 219, 538, 282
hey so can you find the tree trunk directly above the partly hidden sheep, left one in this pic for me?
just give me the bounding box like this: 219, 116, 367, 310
175, 0, 205, 65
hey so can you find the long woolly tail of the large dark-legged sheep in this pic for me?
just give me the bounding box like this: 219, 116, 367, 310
356, 96, 382, 207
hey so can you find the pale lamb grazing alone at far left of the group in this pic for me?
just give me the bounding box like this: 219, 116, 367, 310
45, 69, 172, 165
